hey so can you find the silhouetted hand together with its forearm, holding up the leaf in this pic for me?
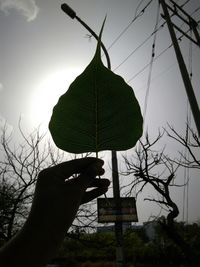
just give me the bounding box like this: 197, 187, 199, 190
0, 158, 110, 267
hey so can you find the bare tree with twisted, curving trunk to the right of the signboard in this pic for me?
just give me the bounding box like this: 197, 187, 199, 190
124, 128, 197, 262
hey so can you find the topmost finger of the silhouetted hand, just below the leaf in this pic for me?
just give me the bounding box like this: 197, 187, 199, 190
48, 157, 104, 180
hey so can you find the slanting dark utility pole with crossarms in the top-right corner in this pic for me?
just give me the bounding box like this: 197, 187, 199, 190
159, 0, 200, 136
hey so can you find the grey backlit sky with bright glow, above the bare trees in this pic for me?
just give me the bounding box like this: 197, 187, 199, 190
0, 0, 200, 225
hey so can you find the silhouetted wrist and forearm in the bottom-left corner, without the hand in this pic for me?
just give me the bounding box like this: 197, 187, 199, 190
0, 214, 65, 267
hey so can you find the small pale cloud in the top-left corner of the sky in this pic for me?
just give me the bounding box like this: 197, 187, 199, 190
0, 0, 39, 21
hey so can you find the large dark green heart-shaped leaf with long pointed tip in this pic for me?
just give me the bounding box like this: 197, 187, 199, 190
49, 21, 143, 153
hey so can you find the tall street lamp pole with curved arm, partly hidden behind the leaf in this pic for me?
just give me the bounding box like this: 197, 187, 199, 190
61, 4, 124, 267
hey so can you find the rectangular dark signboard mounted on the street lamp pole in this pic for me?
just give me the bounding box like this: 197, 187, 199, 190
97, 197, 138, 223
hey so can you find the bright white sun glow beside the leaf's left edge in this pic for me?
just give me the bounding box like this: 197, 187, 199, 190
29, 68, 82, 127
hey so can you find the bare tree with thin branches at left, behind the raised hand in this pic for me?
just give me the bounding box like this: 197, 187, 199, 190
0, 123, 63, 240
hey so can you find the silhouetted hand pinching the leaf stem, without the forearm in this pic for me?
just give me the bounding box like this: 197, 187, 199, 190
29, 158, 110, 234
